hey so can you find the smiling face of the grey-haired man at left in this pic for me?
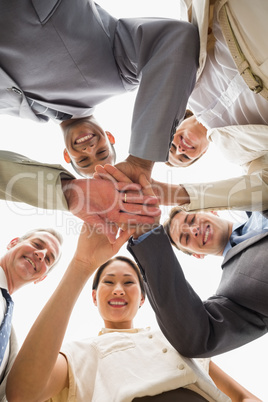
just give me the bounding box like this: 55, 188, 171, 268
7, 232, 61, 285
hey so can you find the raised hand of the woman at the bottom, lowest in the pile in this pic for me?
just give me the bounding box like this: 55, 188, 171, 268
74, 223, 135, 273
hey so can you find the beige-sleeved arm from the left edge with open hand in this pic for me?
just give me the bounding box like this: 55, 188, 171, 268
0, 151, 160, 241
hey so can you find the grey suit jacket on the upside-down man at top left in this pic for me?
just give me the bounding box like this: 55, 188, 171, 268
0, 0, 199, 161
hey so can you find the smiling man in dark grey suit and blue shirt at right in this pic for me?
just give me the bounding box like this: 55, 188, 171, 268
128, 211, 268, 357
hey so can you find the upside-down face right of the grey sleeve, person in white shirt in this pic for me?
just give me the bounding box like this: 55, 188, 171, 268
168, 116, 209, 167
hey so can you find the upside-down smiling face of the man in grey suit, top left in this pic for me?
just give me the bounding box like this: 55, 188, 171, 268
61, 117, 114, 177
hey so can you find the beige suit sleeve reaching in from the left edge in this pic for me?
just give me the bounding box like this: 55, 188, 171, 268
0, 151, 75, 210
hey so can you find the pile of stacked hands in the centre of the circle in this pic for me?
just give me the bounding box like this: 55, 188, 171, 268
62, 156, 164, 243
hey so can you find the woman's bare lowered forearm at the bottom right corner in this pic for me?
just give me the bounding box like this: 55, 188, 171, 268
209, 361, 261, 402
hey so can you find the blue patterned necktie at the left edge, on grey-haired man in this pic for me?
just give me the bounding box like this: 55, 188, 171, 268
0, 288, 14, 365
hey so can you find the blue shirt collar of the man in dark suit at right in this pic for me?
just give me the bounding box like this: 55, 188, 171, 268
223, 211, 268, 257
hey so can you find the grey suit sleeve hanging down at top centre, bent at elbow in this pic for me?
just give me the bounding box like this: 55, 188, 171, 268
115, 18, 199, 162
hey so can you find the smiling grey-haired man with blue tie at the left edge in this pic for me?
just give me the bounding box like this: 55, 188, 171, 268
0, 229, 62, 400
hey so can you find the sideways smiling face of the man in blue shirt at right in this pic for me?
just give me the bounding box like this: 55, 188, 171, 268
170, 211, 231, 255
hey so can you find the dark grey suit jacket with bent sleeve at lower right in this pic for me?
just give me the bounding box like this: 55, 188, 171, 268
128, 227, 268, 357
